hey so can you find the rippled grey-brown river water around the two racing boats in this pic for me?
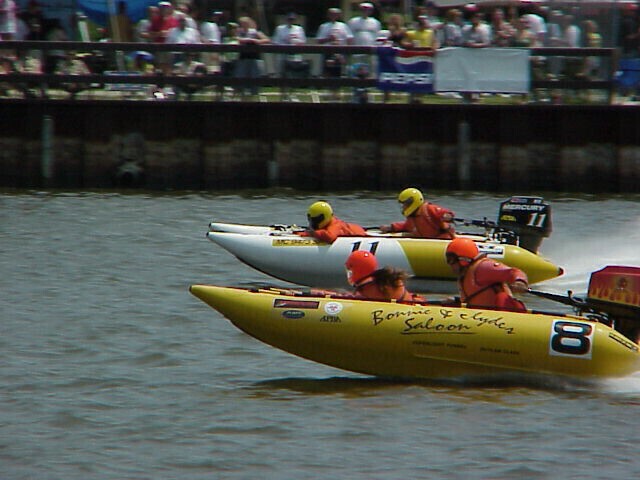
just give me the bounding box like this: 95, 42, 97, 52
0, 191, 640, 480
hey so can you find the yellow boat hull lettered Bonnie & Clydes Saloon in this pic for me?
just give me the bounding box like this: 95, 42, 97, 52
190, 285, 640, 379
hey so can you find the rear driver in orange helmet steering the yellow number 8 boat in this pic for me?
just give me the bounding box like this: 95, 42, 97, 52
446, 237, 529, 312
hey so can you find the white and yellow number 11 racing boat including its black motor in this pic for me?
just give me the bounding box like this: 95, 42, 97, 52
207, 197, 563, 292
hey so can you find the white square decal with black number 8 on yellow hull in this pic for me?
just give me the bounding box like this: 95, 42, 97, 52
549, 320, 595, 360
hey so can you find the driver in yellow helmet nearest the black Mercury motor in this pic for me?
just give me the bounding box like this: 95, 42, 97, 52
380, 188, 455, 240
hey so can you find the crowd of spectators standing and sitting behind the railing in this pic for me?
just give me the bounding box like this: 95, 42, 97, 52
0, 0, 640, 100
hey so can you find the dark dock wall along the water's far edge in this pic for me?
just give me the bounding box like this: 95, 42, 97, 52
0, 101, 640, 193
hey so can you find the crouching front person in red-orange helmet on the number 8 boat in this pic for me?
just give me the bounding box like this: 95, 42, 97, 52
344, 250, 425, 302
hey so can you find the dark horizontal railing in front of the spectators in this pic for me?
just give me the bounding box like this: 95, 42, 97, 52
0, 41, 617, 102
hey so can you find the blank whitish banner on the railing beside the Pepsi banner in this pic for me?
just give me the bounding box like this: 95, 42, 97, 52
434, 48, 531, 93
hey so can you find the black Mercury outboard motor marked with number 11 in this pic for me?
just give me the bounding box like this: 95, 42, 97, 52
497, 196, 552, 253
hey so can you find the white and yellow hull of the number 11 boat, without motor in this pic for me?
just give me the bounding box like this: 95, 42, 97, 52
207, 224, 562, 292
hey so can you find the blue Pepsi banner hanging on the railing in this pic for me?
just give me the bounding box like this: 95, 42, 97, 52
376, 47, 433, 93
